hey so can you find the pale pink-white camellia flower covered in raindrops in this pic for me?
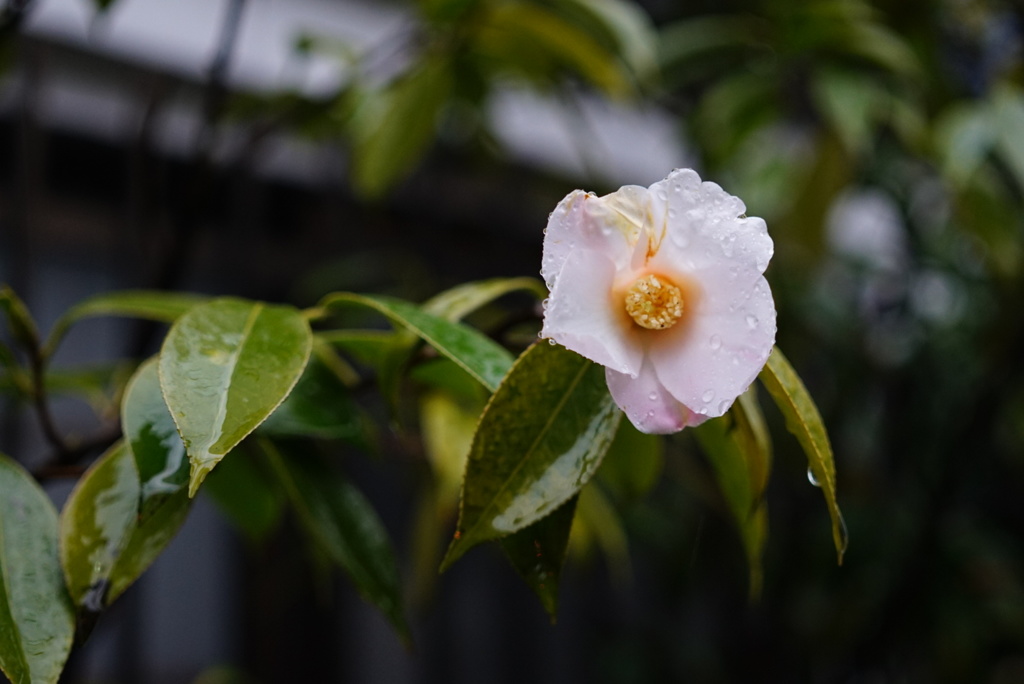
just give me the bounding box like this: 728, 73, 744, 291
541, 169, 775, 433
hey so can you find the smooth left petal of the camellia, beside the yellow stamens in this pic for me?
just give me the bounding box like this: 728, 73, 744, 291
541, 249, 643, 376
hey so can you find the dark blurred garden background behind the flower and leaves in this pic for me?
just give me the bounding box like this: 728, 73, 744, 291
0, 0, 1024, 684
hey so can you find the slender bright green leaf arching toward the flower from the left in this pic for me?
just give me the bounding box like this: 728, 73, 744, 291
322, 293, 513, 391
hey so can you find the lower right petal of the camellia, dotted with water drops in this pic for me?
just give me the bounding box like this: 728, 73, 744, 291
648, 276, 775, 417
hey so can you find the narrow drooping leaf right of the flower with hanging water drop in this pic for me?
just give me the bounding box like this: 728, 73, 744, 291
759, 347, 849, 564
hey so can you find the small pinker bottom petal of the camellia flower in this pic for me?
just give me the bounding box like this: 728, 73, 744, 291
604, 359, 706, 434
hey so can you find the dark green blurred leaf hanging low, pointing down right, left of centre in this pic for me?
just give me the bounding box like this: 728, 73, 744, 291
262, 440, 409, 639
